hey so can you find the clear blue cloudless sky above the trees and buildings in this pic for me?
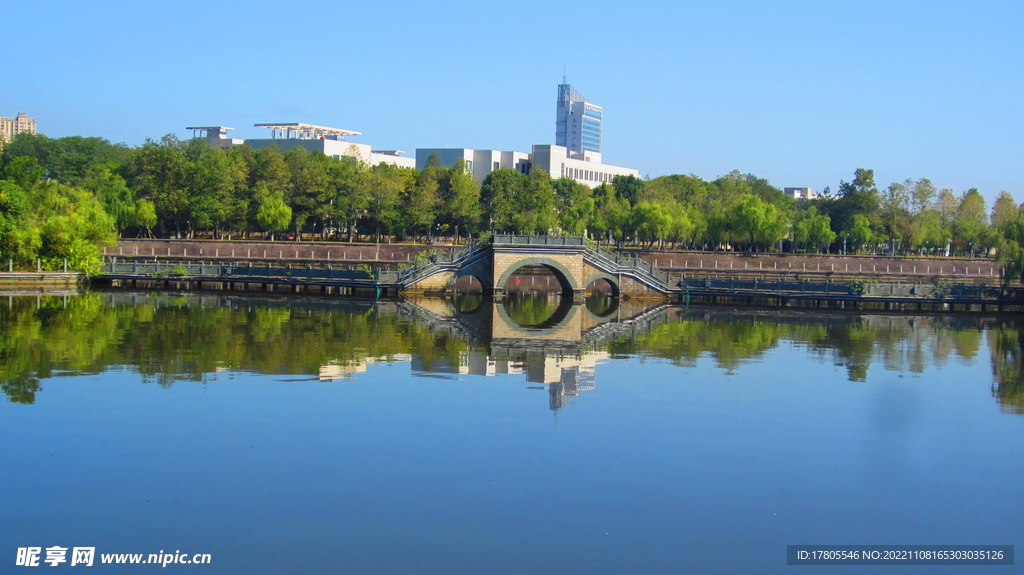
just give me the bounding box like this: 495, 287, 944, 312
0, 0, 1024, 202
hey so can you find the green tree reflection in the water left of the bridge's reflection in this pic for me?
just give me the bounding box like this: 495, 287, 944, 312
0, 294, 466, 403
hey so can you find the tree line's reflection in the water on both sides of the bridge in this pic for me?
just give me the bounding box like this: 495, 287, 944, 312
0, 294, 1024, 413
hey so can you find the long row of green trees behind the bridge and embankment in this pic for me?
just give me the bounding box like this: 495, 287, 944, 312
0, 134, 1024, 271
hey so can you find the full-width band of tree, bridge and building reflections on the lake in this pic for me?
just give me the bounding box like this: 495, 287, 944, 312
8, 290, 1024, 413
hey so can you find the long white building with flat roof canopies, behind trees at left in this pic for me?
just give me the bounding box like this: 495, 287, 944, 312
185, 122, 416, 168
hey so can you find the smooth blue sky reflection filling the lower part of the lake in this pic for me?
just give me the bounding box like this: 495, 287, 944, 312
0, 333, 1024, 574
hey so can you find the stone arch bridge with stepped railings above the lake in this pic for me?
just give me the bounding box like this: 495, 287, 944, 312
398, 234, 673, 301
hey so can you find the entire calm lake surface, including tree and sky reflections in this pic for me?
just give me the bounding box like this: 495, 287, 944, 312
0, 292, 1024, 574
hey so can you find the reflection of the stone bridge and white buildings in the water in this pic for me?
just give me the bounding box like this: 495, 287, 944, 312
399, 292, 670, 410
